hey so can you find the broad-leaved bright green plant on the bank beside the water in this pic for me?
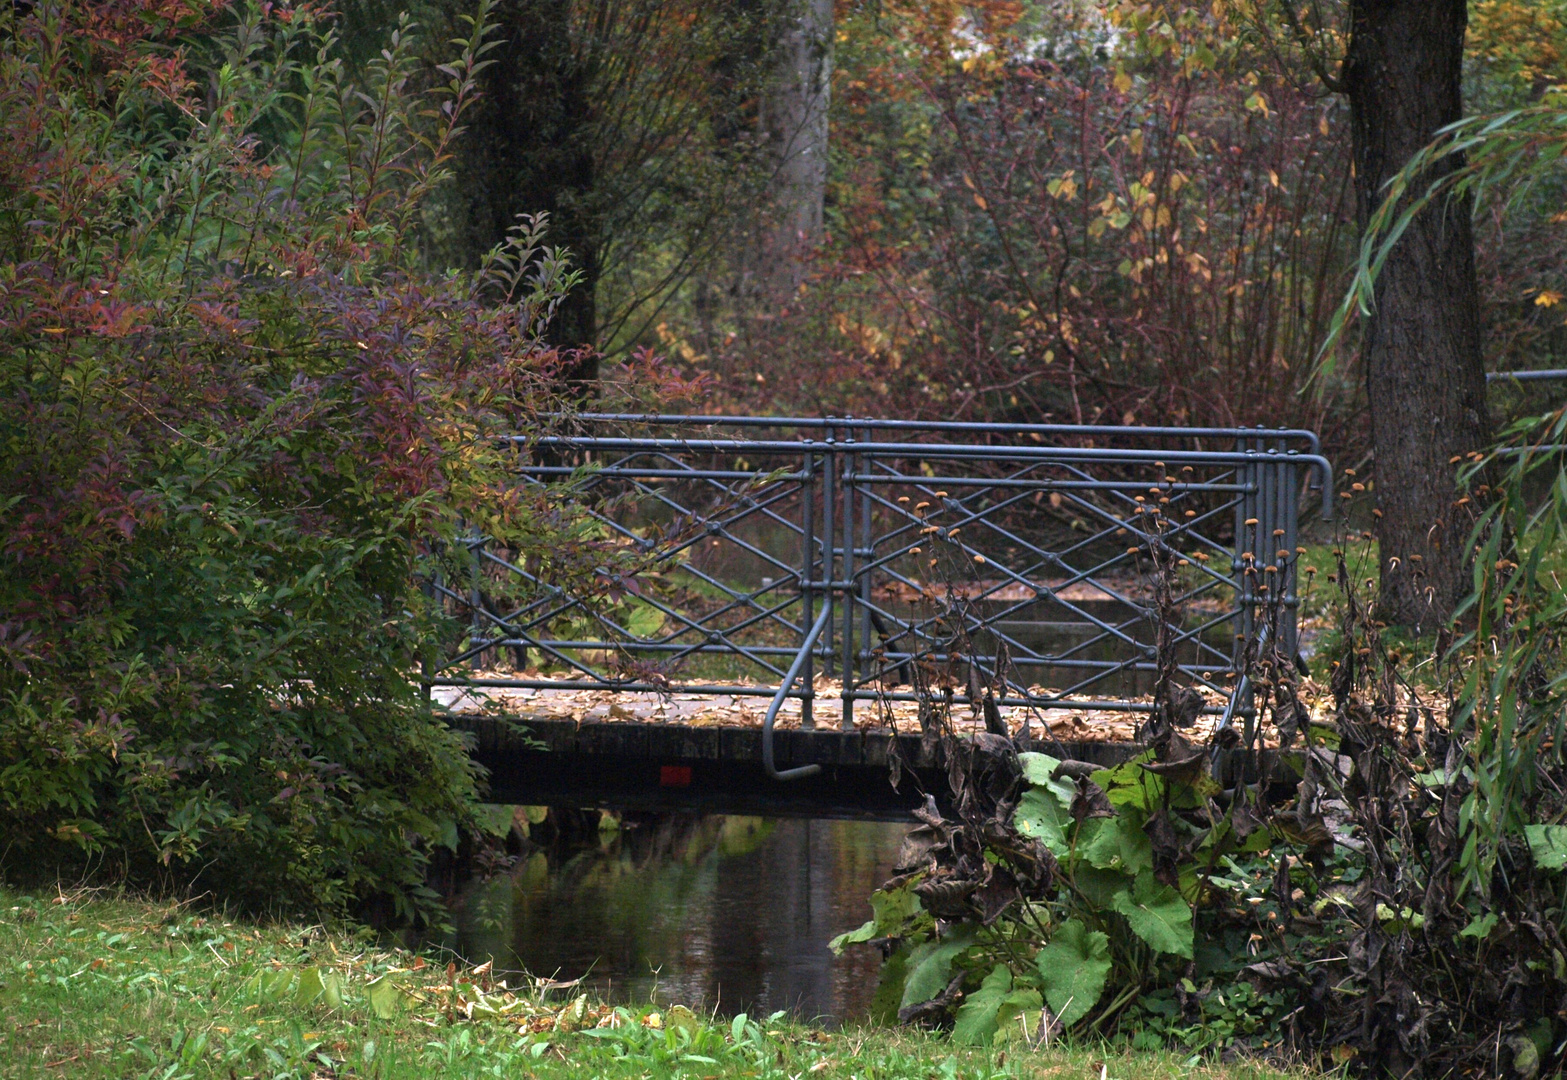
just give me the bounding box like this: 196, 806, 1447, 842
832, 739, 1277, 1042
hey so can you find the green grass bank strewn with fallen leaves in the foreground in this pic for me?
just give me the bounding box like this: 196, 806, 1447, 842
0, 890, 1308, 1080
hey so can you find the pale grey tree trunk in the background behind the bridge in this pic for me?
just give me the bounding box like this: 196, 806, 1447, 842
747, 0, 832, 306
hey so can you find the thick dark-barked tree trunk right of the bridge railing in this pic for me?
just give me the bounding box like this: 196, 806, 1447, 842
1344, 0, 1489, 629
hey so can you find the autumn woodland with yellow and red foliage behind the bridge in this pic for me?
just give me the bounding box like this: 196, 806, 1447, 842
382, 0, 1567, 442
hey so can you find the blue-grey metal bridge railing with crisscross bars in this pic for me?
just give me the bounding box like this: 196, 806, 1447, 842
426, 415, 1332, 774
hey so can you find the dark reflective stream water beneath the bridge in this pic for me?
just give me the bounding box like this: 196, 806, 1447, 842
458, 815, 906, 1020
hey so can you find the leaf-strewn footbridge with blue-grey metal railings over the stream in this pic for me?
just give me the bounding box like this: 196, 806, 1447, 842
423, 414, 1334, 818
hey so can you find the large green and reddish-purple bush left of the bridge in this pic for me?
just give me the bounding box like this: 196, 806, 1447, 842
0, 0, 572, 920
